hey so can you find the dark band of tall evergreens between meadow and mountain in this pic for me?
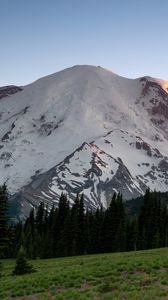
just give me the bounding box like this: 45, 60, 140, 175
0, 185, 168, 258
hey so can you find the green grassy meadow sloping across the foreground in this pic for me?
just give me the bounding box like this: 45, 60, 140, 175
0, 249, 168, 300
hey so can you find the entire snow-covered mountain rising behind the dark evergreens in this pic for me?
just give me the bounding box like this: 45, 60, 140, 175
0, 65, 168, 214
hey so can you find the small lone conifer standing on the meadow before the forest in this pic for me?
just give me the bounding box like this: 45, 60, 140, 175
12, 246, 35, 275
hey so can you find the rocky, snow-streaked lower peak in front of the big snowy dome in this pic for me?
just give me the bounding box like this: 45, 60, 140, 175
16, 130, 168, 216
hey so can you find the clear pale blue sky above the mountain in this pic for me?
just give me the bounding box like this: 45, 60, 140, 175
0, 0, 168, 86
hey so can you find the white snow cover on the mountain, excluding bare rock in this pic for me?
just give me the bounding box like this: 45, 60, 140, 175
0, 65, 168, 201
